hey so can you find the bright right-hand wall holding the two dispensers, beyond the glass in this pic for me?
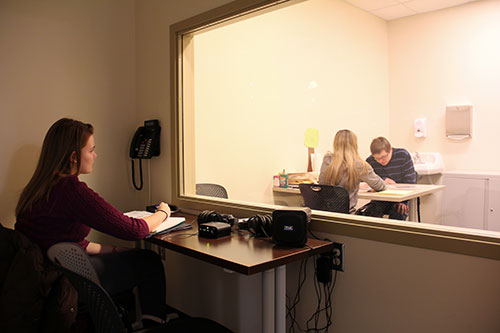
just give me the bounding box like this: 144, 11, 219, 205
388, 0, 500, 171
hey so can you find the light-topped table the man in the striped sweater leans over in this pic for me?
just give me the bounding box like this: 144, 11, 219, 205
273, 183, 445, 222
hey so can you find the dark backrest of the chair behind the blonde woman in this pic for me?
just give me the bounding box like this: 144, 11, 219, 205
299, 184, 349, 213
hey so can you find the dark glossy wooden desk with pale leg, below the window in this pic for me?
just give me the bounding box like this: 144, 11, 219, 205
148, 213, 333, 332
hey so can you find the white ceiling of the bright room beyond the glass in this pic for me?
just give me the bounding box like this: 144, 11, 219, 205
345, 0, 477, 21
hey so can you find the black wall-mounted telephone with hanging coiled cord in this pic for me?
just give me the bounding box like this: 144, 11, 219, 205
130, 119, 161, 191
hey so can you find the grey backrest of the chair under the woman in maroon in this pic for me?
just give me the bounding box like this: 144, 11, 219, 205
47, 242, 101, 285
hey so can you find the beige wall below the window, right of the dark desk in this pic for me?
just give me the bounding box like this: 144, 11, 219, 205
287, 234, 500, 333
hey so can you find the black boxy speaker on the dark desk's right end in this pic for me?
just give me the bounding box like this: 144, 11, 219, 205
272, 207, 311, 247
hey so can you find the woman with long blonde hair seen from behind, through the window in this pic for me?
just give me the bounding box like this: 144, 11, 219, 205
319, 129, 385, 212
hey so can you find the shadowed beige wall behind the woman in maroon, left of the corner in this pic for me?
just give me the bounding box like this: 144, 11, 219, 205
0, 0, 136, 246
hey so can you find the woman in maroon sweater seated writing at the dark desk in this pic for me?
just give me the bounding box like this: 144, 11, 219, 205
15, 118, 170, 318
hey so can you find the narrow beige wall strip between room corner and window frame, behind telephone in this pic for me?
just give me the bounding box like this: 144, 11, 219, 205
136, 0, 235, 206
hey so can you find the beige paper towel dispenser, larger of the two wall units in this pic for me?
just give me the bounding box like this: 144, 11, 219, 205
446, 105, 472, 140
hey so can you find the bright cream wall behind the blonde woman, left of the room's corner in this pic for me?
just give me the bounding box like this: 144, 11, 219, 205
193, 0, 389, 204
